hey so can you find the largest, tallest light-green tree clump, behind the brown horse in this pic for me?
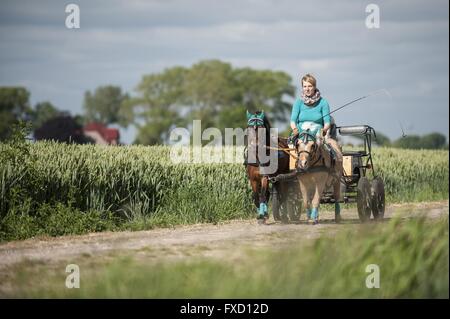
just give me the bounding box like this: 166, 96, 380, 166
132, 60, 295, 144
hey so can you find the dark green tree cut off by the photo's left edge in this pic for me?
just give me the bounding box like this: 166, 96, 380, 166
0, 87, 31, 140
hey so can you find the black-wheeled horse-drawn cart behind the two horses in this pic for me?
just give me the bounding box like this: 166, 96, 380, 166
270, 125, 385, 222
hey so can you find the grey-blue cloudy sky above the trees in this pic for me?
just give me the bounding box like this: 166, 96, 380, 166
0, 0, 449, 143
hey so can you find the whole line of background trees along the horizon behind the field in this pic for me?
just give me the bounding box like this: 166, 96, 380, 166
0, 60, 448, 148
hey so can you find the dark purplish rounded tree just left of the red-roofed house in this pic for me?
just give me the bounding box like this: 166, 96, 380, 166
34, 114, 93, 144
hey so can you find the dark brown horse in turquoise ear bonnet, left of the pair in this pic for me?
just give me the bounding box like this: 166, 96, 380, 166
244, 111, 289, 222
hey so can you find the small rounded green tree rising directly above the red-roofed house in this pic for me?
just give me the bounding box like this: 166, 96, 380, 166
83, 85, 132, 127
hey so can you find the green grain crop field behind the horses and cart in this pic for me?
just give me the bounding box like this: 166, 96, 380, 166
0, 142, 449, 240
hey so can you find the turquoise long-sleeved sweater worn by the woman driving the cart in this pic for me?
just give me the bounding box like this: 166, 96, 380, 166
291, 97, 330, 135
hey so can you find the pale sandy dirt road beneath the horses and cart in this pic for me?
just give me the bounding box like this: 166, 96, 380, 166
0, 201, 449, 271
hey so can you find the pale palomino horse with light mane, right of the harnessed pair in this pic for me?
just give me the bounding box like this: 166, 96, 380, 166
297, 131, 343, 224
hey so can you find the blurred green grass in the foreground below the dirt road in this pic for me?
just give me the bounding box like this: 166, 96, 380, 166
6, 217, 449, 298
